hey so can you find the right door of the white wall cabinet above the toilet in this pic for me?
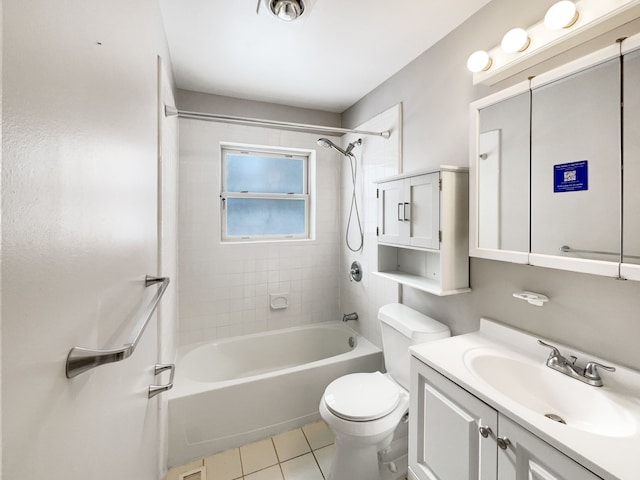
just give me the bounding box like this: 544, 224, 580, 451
410, 172, 440, 249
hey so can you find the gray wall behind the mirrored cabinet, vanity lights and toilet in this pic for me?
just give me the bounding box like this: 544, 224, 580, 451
343, 0, 640, 368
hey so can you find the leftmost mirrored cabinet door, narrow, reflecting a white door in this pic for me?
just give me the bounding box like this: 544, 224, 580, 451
469, 82, 531, 264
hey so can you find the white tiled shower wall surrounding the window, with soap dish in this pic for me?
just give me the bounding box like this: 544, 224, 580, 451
179, 119, 343, 344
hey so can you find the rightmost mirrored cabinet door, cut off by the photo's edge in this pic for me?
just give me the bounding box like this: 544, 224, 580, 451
622, 50, 640, 274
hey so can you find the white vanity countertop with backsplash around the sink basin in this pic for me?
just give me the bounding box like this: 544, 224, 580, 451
411, 318, 640, 480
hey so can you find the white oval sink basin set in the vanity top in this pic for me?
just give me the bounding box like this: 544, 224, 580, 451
464, 348, 637, 437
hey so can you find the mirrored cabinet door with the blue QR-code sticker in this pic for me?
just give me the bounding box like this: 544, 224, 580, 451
530, 58, 621, 276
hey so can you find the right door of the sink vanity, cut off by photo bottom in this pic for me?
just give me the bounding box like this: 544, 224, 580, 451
498, 415, 601, 480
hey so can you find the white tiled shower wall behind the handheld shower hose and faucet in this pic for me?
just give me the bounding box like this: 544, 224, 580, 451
340, 105, 402, 347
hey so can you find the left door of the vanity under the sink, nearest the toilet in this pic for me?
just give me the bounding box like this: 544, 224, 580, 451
409, 357, 498, 480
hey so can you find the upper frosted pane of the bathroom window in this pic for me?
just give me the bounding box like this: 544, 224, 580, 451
226, 154, 305, 194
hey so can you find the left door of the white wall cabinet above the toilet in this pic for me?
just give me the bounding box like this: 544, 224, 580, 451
378, 179, 407, 244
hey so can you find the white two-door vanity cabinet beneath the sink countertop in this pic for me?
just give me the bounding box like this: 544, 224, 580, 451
409, 357, 601, 480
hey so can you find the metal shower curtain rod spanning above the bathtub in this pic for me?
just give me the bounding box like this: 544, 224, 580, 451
164, 105, 391, 138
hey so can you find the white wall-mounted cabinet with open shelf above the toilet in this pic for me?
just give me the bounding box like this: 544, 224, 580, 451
374, 166, 469, 295
